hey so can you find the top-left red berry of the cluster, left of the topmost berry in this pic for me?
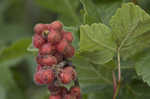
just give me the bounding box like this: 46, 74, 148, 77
34, 24, 48, 34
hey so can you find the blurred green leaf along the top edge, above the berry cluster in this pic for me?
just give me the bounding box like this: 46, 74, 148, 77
36, 0, 80, 24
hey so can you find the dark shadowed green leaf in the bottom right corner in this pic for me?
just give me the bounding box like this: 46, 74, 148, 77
118, 80, 150, 99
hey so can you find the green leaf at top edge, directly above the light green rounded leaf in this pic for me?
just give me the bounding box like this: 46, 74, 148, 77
80, 0, 101, 24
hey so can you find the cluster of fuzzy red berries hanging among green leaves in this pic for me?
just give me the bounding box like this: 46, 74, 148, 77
33, 21, 81, 99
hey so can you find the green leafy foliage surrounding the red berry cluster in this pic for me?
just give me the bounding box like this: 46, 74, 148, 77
0, 0, 150, 99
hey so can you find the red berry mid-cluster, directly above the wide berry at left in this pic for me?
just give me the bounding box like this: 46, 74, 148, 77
39, 43, 55, 55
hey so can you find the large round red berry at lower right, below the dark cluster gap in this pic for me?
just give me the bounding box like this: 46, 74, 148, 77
59, 66, 76, 84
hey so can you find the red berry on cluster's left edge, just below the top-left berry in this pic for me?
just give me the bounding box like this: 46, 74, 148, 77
33, 34, 45, 48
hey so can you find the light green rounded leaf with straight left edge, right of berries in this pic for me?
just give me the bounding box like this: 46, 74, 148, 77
79, 23, 115, 64
